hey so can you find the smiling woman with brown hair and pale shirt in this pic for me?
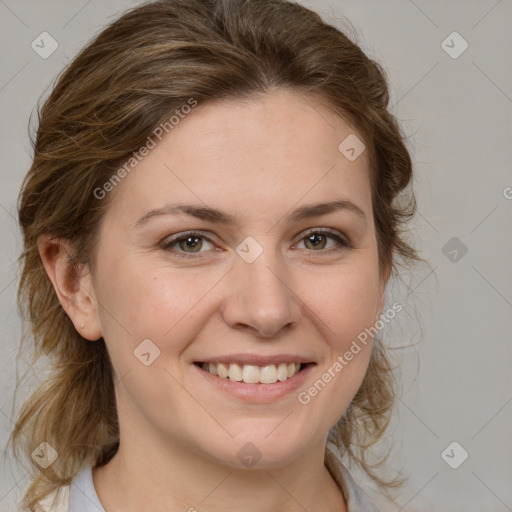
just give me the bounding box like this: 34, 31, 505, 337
12, 0, 419, 512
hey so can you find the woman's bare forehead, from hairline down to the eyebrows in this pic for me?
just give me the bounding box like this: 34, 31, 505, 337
105, 89, 370, 222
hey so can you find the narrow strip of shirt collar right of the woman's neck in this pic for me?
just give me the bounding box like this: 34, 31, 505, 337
325, 443, 379, 512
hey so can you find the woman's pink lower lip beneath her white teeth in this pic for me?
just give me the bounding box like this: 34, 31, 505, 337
192, 364, 315, 403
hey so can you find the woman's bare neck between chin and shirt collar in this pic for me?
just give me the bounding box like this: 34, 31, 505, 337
93, 433, 347, 512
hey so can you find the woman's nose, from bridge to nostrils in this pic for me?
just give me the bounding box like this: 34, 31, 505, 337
221, 246, 302, 338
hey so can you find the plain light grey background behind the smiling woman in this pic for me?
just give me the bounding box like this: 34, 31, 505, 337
0, 0, 512, 512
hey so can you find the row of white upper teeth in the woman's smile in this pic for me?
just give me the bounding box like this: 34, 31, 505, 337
202, 363, 300, 384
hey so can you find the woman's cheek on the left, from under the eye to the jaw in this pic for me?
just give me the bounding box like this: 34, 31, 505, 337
92, 258, 204, 421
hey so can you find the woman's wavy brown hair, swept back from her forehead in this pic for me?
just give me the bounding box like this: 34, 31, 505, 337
11, 0, 420, 508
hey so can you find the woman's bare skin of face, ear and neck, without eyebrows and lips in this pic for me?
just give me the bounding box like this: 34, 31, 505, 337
40, 89, 389, 512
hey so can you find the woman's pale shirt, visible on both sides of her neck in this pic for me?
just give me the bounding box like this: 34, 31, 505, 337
30, 443, 379, 512
